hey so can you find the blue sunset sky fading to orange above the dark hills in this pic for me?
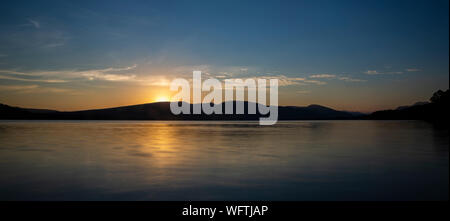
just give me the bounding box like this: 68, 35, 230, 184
0, 0, 449, 112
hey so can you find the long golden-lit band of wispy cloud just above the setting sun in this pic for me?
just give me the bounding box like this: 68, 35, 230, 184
0, 64, 367, 91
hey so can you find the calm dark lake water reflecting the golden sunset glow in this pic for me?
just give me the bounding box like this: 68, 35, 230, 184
0, 121, 449, 200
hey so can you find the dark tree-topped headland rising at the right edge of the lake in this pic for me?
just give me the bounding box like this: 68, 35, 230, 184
363, 89, 450, 123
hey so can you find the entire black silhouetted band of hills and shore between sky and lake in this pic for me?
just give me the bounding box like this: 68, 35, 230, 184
0, 90, 449, 121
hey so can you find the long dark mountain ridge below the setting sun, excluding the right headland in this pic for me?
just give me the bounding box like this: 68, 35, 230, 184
0, 101, 362, 120
